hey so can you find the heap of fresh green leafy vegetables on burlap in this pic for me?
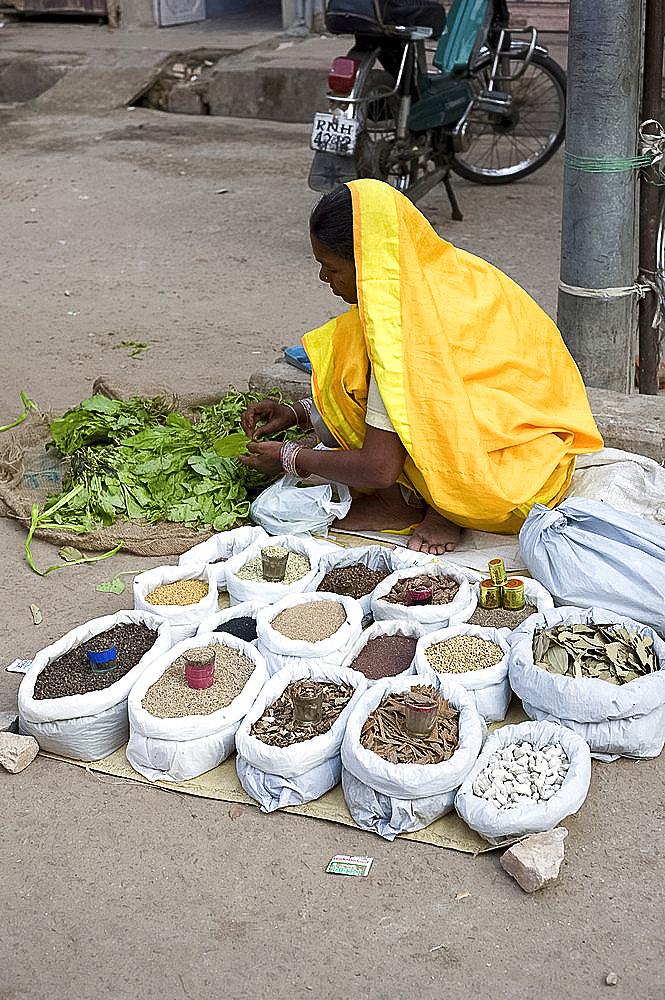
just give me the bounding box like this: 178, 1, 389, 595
43, 389, 302, 532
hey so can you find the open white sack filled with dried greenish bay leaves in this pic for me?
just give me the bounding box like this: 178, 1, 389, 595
509, 608, 665, 760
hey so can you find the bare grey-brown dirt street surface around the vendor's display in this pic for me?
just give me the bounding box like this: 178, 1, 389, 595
0, 68, 665, 1000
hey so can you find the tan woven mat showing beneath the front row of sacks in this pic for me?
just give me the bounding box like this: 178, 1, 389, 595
41, 699, 526, 854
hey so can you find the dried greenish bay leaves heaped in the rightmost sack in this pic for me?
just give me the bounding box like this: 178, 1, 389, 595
533, 623, 659, 684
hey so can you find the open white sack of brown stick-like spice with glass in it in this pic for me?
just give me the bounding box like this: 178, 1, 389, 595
342, 676, 486, 840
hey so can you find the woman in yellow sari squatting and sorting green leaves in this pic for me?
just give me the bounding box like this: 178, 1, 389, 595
241, 179, 603, 554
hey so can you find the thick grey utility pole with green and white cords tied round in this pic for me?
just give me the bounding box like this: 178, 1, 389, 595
558, 0, 643, 393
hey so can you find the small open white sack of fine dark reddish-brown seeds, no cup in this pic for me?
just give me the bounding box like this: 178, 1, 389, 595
342, 618, 427, 687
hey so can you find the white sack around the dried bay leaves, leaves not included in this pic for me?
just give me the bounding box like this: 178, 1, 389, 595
509, 607, 665, 760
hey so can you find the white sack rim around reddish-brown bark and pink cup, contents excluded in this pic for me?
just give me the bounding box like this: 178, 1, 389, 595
371, 559, 477, 631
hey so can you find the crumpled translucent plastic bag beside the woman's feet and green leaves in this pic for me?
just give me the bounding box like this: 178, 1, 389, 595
249, 476, 351, 536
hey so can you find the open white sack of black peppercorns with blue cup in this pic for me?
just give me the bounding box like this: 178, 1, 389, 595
18, 611, 171, 760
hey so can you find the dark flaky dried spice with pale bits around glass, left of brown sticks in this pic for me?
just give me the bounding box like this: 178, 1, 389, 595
250, 680, 355, 747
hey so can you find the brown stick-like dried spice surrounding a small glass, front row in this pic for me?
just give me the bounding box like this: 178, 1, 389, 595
360, 684, 459, 764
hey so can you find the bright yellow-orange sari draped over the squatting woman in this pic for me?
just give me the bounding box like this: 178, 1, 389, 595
303, 180, 603, 533
